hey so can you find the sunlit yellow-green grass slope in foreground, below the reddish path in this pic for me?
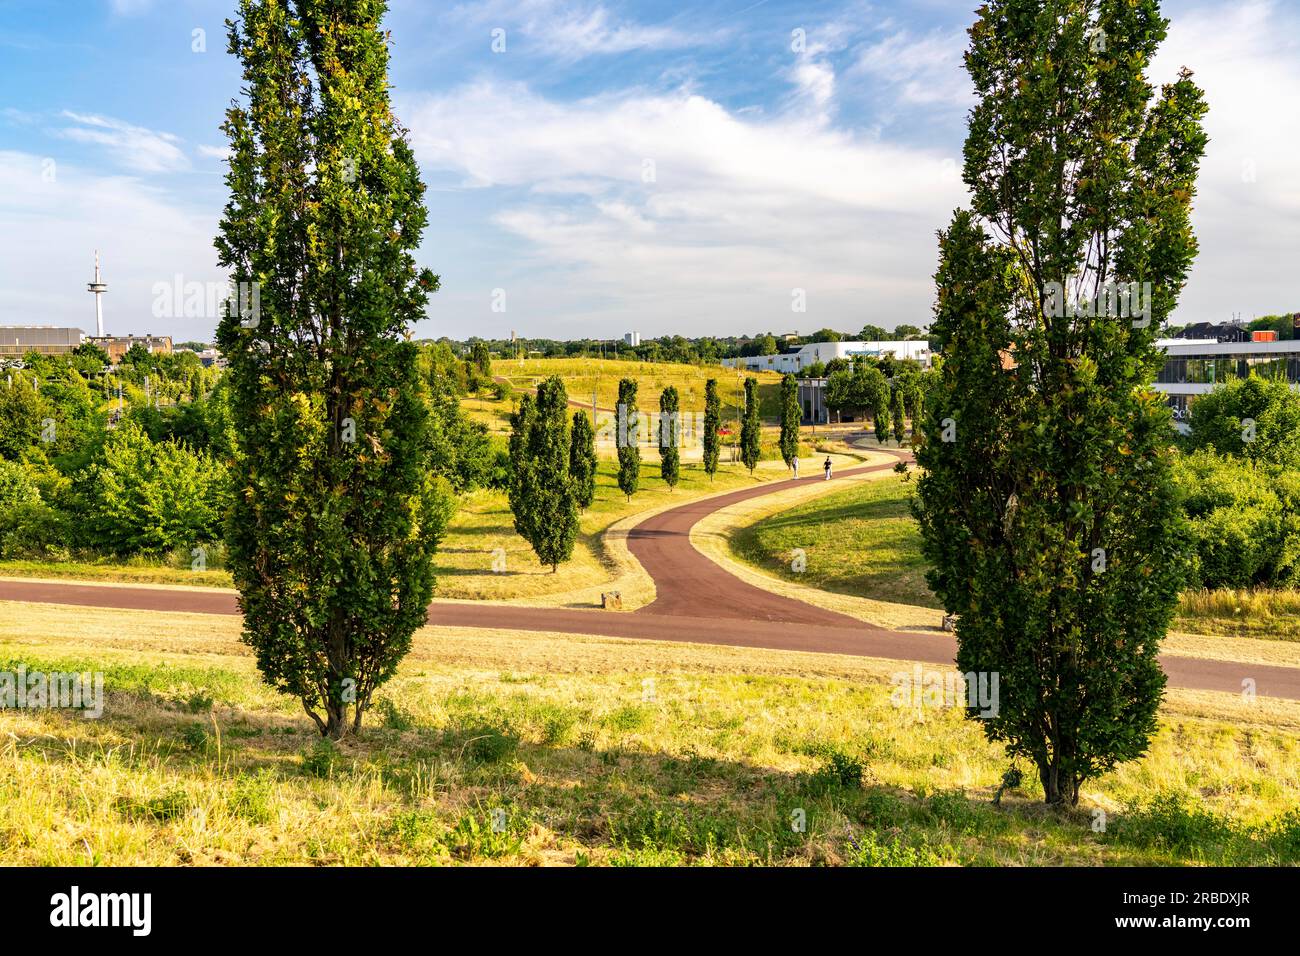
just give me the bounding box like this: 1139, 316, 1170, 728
0, 604, 1300, 865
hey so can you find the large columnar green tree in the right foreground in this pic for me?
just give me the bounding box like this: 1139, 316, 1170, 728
917, 0, 1206, 804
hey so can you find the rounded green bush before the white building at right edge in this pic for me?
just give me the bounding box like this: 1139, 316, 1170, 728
1186, 373, 1300, 468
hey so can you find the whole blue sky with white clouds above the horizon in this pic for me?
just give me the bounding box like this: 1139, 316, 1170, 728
0, 0, 1300, 339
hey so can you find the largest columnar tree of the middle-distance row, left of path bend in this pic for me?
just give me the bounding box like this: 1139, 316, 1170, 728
527, 375, 577, 572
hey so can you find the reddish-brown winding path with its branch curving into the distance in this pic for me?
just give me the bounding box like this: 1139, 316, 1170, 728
0, 453, 1300, 700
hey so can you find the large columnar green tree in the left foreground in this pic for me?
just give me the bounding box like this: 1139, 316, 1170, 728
216, 0, 449, 739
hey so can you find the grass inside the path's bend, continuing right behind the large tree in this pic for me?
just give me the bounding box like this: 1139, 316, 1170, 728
729, 475, 1300, 641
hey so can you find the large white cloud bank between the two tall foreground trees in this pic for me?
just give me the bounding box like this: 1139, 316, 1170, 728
399, 77, 965, 334
